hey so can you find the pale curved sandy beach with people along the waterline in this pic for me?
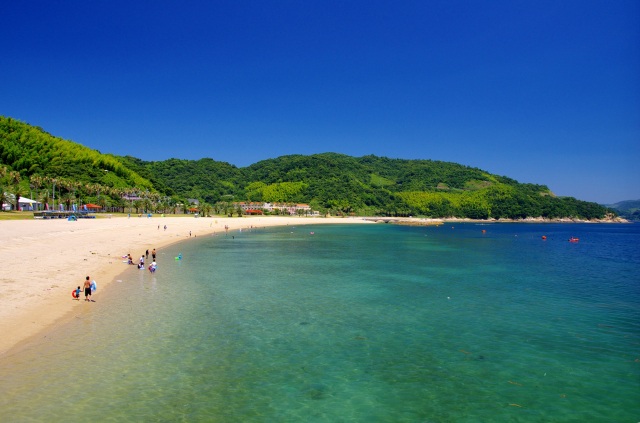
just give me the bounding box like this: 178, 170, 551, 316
0, 217, 366, 356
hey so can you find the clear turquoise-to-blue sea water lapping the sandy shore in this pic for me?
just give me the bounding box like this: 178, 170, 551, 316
0, 223, 640, 423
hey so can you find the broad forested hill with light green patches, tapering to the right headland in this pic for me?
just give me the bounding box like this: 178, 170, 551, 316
238, 153, 607, 219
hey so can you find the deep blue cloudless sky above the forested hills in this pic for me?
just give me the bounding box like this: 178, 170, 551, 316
0, 0, 640, 203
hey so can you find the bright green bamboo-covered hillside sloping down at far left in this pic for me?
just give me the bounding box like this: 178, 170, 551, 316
0, 116, 157, 209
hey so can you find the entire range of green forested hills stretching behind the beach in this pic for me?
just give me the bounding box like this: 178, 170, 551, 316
0, 117, 611, 219
